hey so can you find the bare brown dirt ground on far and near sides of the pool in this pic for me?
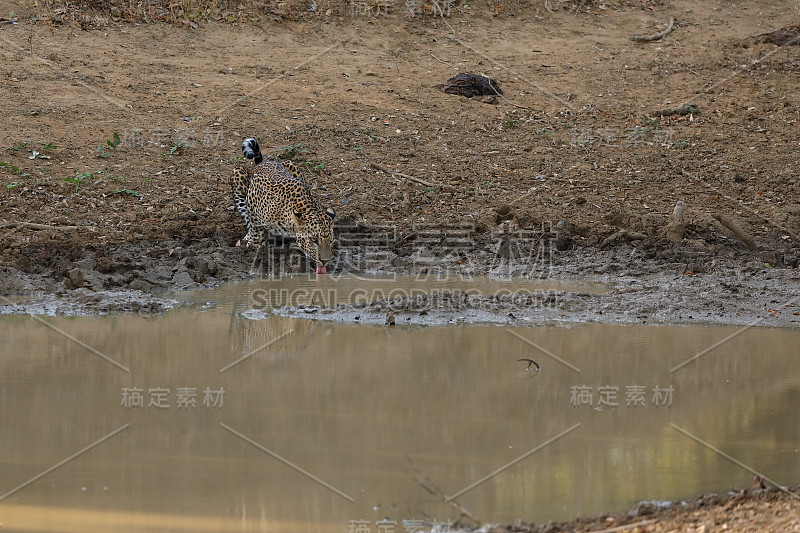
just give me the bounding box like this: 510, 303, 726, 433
0, 0, 800, 531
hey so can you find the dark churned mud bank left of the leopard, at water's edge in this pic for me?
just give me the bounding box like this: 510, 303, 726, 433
0, 241, 234, 315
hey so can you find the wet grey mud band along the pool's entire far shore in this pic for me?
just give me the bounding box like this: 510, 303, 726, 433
0, 237, 800, 327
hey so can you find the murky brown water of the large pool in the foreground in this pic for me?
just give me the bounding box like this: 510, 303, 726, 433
0, 280, 800, 532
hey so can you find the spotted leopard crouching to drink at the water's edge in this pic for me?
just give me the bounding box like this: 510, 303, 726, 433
231, 137, 336, 274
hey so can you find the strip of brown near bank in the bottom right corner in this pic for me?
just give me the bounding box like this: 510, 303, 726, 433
456, 487, 800, 533
